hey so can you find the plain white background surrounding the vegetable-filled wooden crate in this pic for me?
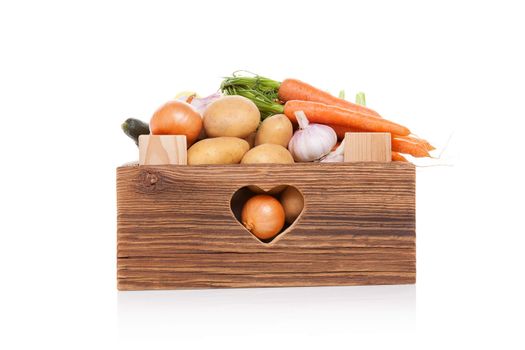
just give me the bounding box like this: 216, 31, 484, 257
0, 0, 525, 349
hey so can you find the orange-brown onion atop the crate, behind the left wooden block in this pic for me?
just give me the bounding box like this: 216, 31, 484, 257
150, 101, 202, 146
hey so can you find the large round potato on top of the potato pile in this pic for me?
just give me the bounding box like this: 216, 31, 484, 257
203, 96, 261, 139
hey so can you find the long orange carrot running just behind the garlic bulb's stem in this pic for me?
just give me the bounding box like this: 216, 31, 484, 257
284, 101, 410, 136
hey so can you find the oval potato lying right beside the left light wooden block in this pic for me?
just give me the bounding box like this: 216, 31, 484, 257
188, 137, 250, 165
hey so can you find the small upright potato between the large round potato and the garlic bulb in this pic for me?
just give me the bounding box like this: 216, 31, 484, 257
255, 114, 293, 147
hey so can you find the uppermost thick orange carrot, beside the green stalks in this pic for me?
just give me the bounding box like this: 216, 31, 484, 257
278, 79, 380, 117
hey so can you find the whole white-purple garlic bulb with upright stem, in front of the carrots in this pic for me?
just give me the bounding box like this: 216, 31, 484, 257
288, 111, 337, 162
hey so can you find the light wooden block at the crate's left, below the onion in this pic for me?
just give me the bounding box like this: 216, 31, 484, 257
139, 135, 188, 165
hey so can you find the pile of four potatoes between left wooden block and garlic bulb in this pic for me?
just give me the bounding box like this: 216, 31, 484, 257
188, 96, 294, 165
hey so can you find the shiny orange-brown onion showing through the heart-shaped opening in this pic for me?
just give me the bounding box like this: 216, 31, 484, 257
241, 194, 284, 239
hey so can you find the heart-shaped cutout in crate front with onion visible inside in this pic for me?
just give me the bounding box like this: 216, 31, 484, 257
230, 185, 304, 244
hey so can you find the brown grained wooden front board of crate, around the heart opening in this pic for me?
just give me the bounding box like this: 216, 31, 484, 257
117, 162, 416, 290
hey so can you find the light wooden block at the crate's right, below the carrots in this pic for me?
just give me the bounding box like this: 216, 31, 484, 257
344, 132, 392, 162
